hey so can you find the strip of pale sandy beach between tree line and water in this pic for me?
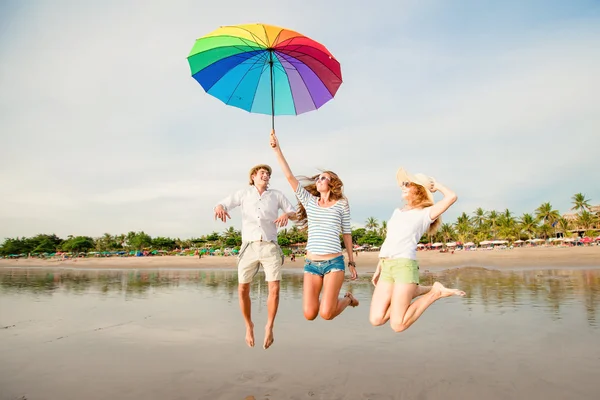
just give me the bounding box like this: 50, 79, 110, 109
0, 246, 600, 271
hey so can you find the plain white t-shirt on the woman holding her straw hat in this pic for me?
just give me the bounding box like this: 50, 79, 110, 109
379, 207, 433, 260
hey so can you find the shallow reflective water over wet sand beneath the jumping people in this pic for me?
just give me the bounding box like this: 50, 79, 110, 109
0, 268, 600, 400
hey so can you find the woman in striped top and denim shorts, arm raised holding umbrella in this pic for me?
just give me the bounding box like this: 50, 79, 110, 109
271, 131, 358, 320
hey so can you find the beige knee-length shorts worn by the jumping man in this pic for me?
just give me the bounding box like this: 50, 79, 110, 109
238, 241, 283, 283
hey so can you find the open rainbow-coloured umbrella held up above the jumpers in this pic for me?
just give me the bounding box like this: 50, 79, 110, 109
188, 24, 342, 129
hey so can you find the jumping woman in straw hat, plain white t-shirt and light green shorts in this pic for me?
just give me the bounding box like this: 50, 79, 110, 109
369, 168, 465, 332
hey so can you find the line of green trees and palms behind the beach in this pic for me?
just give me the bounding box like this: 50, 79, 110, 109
0, 193, 600, 256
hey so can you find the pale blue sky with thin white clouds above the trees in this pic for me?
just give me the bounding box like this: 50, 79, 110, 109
0, 0, 600, 240
